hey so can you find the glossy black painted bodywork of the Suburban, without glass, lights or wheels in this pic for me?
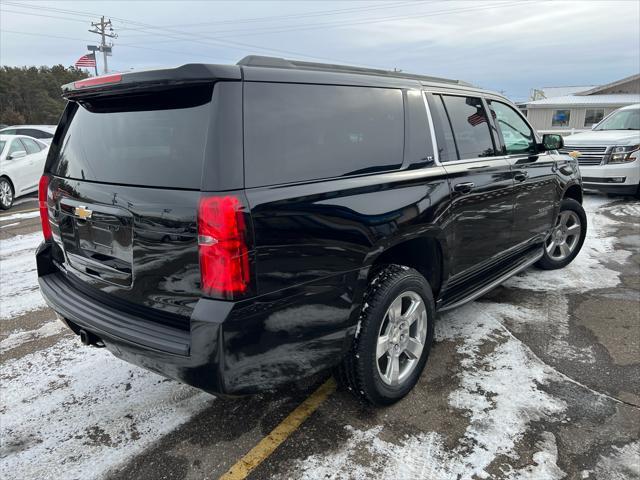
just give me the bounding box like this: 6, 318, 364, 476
37, 67, 580, 394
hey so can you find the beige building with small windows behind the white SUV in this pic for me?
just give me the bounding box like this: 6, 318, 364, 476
520, 74, 640, 135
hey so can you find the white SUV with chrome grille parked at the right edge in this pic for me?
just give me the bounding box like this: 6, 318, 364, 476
562, 104, 640, 195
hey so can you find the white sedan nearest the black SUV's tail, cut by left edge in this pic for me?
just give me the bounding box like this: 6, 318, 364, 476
0, 134, 49, 210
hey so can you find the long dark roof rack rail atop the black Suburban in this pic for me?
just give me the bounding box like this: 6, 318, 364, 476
237, 55, 473, 87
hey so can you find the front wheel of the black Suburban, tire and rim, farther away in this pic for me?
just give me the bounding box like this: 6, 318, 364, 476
536, 198, 587, 270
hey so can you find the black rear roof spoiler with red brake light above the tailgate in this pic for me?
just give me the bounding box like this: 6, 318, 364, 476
62, 63, 242, 100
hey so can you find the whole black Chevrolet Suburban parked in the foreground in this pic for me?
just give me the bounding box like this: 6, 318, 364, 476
37, 56, 587, 405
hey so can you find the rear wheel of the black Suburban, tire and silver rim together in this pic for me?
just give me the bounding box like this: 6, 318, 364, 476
336, 265, 435, 406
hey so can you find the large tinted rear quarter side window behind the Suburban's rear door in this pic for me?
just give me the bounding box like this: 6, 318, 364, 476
244, 83, 404, 187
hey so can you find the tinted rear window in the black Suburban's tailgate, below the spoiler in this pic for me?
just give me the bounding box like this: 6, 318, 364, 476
51, 86, 212, 189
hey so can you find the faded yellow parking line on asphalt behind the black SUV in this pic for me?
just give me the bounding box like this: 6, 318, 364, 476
220, 378, 336, 480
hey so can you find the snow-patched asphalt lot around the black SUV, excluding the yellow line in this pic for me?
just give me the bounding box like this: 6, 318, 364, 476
0, 195, 640, 479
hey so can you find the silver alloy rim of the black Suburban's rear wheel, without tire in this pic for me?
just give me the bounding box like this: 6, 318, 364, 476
376, 291, 428, 386
